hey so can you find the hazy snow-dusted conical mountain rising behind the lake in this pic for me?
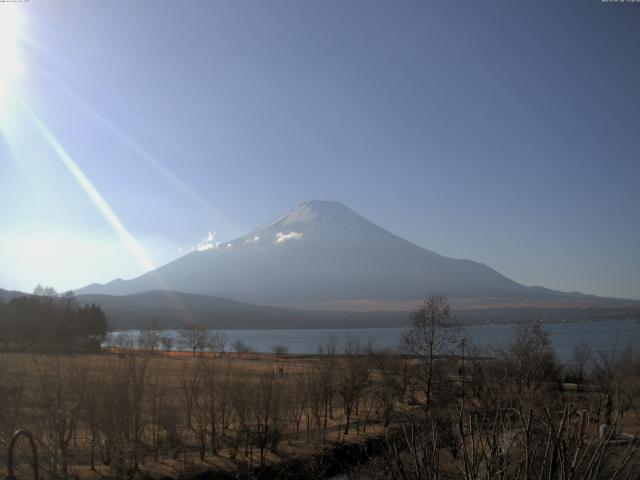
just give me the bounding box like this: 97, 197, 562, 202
78, 201, 584, 305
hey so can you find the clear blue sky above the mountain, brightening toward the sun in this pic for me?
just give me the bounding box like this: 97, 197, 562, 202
0, 0, 640, 298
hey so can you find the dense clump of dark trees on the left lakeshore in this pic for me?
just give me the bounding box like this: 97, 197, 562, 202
0, 285, 108, 352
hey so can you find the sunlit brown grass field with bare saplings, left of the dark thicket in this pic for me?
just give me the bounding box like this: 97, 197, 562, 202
0, 352, 398, 478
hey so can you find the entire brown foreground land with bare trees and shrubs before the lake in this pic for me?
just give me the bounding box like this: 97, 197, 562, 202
0, 322, 640, 480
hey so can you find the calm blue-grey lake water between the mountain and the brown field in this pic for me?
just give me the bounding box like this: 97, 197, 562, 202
106, 320, 640, 360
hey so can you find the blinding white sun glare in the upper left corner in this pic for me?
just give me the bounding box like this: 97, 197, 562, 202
0, 3, 24, 112
